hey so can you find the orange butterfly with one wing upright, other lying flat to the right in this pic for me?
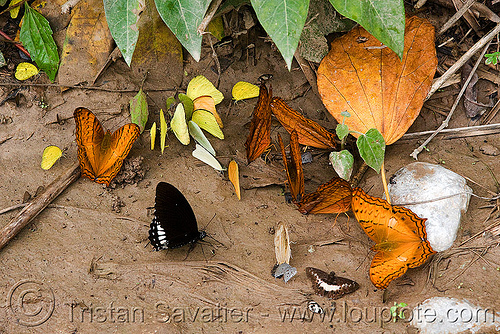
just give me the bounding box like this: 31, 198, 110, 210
278, 130, 352, 214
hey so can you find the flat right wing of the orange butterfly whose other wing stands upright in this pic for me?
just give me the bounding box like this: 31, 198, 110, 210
297, 177, 352, 214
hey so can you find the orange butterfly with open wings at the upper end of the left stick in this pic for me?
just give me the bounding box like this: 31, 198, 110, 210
74, 108, 140, 186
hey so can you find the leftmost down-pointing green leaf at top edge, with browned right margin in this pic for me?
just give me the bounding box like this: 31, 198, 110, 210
104, 0, 144, 66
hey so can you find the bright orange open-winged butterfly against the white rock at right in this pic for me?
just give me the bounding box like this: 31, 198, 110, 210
352, 188, 435, 289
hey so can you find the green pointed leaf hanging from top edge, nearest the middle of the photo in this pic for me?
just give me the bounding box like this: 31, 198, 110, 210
251, 0, 309, 70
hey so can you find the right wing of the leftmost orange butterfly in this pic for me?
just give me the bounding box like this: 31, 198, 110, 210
95, 123, 141, 186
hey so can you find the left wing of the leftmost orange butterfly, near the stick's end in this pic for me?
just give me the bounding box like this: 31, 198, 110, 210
73, 107, 104, 180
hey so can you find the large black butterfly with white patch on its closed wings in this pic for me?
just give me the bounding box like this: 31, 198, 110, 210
149, 182, 205, 250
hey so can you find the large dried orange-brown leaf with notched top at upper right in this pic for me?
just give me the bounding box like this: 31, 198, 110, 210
318, 16, 437, 144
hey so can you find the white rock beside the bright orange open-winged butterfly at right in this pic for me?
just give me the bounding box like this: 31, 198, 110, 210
389, 162, 472, 252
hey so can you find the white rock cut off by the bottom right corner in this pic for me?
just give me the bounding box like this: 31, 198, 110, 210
410, 297, 500, 334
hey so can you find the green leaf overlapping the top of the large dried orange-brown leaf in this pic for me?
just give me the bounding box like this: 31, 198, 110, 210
330, 0, 405, 58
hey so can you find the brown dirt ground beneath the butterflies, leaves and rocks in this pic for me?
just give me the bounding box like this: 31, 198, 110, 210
0, 3, 500, 333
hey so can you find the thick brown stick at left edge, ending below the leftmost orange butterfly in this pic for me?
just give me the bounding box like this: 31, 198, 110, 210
0, 164, 80, 249
